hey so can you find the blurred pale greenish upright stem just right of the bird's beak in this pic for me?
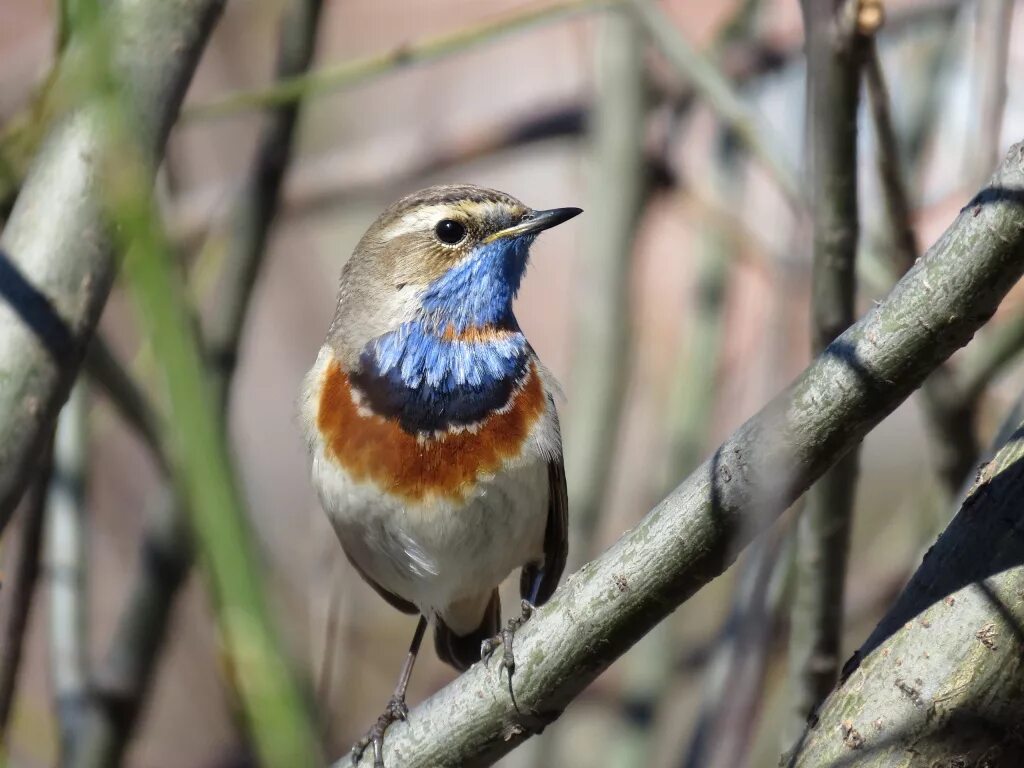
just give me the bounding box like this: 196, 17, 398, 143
565, 6, 649, 565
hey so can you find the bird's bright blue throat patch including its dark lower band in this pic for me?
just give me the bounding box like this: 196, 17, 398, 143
350, 238, 532, 432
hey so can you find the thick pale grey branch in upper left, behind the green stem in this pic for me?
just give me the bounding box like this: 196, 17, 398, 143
0, 0, 223, 530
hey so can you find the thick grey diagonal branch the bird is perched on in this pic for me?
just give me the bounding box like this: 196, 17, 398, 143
339, 144, 1024, 768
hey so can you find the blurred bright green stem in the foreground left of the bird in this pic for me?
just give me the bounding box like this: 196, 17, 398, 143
76, 4, 317, 766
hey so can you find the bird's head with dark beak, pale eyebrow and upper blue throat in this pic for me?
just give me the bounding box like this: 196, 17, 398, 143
331, 184, 582, 361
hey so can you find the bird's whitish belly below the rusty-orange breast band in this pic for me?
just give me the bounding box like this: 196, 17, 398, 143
313, 449, 549, 616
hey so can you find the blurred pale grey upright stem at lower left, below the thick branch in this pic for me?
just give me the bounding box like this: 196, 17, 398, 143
45, 381, 89, 765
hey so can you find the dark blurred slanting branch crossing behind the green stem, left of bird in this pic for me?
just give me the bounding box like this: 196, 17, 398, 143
75, 0, 323, 768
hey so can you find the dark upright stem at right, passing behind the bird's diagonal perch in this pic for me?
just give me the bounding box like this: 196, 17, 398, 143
790, 0, 865, 738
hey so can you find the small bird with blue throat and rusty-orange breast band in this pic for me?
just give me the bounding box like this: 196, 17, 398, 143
300, 184, 583, 768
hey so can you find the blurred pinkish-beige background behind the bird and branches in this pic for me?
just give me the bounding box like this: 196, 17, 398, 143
0, 0, 1024, 768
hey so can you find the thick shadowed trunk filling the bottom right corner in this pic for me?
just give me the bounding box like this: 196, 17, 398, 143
790, 387, 1024, 768
